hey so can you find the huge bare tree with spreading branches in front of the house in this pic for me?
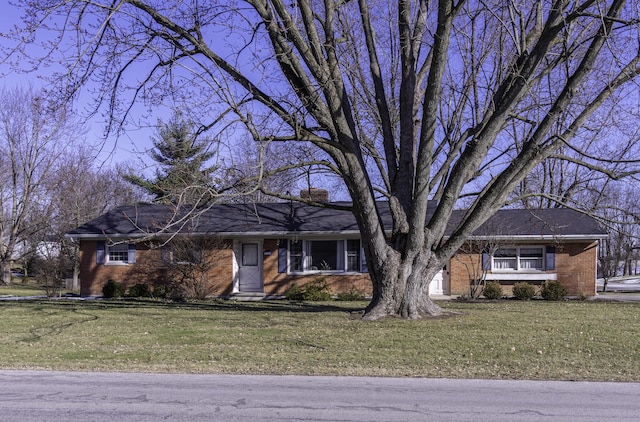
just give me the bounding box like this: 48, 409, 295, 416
6, 0, 640, 319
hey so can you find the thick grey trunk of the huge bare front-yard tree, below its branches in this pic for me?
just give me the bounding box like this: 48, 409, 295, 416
363, 250, 447, 320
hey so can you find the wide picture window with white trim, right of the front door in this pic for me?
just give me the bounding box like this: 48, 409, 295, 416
288, 239, 363, 272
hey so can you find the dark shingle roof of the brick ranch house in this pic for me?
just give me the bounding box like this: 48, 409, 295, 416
67, 202, 606, 238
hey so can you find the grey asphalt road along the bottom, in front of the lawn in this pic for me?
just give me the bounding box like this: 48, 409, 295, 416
0, 371, 640, 422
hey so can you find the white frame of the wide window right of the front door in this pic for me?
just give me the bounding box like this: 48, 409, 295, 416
287, 238, 366, 274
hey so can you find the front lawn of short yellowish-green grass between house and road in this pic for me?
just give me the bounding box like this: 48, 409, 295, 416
0, 300, 640, 381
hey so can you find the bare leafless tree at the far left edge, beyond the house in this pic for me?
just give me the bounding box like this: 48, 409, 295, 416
0, 88, 78, 284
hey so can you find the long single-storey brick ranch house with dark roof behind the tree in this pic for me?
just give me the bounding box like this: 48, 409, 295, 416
67, 202, 606, 297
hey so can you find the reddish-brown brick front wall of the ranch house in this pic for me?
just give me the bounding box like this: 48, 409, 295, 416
80, 239, 597, 296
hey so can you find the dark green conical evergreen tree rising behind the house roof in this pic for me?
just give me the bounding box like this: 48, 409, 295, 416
123, 111, 216, 205
